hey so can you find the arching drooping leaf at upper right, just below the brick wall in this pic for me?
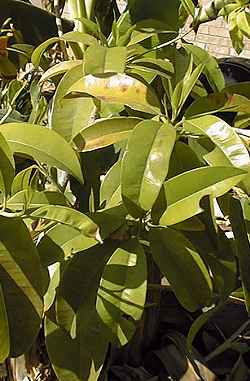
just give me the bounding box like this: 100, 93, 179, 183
182, 44, 225, 92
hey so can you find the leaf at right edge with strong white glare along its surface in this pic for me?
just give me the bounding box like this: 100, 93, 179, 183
184, 115, 250, 192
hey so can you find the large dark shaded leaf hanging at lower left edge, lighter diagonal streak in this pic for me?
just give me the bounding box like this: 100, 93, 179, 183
0, 217, 43, 356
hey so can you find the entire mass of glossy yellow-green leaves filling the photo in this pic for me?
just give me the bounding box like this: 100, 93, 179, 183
0, 1, 250, 381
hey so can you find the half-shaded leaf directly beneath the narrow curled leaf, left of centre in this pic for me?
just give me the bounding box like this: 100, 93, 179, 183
37, 224, 97, 266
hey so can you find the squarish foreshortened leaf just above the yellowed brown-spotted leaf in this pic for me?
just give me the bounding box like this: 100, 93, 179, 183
83, 45, 127, 75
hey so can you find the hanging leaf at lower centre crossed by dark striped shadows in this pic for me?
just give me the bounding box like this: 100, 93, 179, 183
96, 239, 147, 345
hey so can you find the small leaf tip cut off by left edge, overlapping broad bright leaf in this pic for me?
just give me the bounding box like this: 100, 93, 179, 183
0, 133, 15, 194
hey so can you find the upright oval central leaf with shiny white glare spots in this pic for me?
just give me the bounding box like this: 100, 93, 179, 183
121, 120, 176, 218
